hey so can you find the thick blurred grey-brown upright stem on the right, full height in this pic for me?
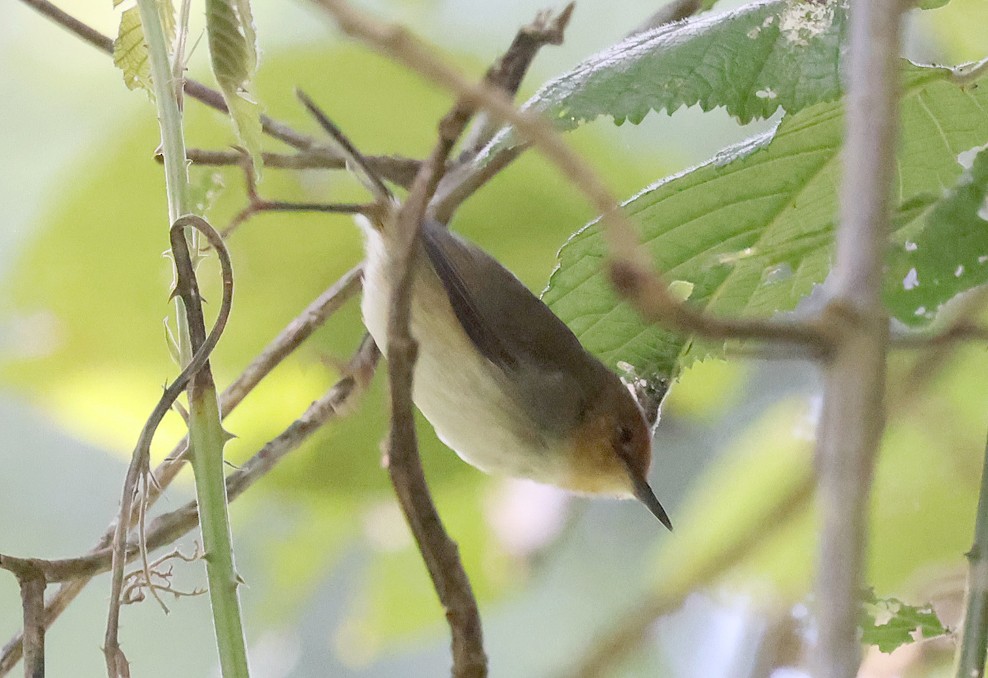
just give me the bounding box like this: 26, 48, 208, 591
812, 0, 904, 678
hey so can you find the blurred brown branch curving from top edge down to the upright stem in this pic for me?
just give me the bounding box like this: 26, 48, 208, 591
313, 0, 831, 353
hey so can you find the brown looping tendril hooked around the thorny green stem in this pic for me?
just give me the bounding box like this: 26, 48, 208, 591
103, 214, 233, 673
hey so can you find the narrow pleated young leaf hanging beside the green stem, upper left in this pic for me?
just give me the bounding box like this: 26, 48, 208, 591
206, 0, 261, 173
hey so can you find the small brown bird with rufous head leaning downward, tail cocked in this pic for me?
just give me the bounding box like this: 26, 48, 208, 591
300, 95, 672, 530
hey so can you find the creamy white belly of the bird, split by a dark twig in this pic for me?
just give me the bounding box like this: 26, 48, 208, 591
361, 233, 561, 483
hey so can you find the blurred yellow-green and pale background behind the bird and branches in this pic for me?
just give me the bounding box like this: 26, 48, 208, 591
0, 0, 988, 678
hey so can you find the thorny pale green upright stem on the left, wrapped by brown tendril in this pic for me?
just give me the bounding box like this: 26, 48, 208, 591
138, 0, 249, 678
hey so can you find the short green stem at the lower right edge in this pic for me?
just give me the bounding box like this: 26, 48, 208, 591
954, 430, 988, 678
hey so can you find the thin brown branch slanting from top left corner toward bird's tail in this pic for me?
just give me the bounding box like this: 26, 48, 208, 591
21, 0, 415, 186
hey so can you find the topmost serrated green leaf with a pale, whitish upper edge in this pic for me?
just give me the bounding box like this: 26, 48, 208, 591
512, 0, 847, 129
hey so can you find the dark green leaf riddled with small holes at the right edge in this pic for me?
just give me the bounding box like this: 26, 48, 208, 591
885, 146, 988, 325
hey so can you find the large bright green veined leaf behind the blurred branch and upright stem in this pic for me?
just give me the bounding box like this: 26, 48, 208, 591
544, 65, 988, 377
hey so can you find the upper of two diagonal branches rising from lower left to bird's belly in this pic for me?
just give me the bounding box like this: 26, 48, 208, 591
0, 267, 361, 676
